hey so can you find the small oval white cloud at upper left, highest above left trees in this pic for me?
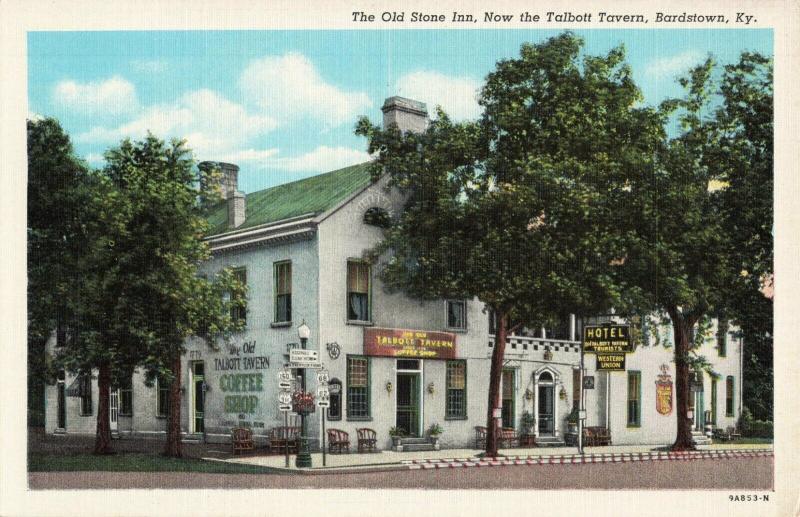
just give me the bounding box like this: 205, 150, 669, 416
53, 75, 138, 115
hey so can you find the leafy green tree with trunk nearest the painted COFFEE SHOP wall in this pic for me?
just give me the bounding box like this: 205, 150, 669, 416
104, 135, 245, 456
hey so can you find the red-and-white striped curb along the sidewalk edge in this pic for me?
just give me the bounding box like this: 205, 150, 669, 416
402, 449, 774, 470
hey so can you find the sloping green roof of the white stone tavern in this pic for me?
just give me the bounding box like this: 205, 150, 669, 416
208, 163, 371, 235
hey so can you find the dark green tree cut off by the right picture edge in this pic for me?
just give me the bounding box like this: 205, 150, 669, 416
715, 52, 774, 420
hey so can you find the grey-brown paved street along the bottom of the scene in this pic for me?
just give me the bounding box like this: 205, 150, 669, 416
29, 457, 773, 490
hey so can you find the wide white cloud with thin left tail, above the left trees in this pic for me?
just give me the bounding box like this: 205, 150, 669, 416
75, 90, 276, 160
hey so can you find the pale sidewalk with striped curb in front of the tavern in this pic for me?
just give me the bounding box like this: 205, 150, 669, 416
209, 443, 772, 474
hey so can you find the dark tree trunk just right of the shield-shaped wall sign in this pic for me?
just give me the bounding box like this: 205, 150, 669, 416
668, 308, 697, 451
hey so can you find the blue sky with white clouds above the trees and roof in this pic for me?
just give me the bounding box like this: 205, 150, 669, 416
28, 29, 773, 196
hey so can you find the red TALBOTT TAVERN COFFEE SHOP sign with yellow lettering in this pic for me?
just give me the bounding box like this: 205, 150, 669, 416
364, 328, 456, 359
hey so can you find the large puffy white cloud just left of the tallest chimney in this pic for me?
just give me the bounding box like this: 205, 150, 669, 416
239, 53, 372, 129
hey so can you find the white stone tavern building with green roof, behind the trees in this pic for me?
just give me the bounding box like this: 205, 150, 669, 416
45, 97, 742, 448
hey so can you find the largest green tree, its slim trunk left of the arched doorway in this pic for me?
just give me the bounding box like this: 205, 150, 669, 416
357, 33, 663, 456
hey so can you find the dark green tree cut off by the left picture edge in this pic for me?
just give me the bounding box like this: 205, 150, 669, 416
27, 118, 89, 428
